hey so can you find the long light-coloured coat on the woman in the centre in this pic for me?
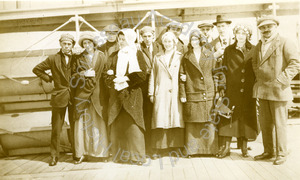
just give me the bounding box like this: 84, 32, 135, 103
149, 51, 184, 129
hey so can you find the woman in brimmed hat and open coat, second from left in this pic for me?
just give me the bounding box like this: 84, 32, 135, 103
71, 32, 108, 164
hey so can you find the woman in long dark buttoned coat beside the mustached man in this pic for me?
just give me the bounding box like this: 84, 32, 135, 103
217, 25, 259, 158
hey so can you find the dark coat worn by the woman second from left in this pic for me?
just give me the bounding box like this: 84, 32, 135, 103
71, 51, 108, 120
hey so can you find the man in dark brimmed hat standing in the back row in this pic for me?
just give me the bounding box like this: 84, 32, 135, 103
211, 15, 235, 61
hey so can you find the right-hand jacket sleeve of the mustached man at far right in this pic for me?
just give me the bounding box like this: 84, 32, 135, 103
277, 40, 300, 86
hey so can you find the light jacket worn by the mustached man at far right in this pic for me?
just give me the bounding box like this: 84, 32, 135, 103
252, 35, 300, 101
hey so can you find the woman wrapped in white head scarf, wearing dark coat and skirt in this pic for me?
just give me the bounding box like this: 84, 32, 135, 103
106, 29, 146, 165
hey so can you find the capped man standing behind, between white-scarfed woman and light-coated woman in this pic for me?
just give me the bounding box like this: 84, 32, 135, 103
137, 26, 161, 155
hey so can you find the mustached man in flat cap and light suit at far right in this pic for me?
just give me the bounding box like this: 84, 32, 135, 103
252, 16, 300, 165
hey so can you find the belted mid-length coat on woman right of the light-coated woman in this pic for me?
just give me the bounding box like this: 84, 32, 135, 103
179, 49, 216, 122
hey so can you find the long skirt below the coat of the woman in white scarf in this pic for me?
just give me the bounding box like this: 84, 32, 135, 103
110, 108, 146, 163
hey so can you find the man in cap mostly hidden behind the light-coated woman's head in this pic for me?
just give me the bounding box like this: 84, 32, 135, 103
156, 22, 187, 54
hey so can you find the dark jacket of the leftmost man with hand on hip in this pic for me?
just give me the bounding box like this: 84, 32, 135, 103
32, 51, 74, 108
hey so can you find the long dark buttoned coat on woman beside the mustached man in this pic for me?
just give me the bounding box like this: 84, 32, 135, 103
219, 42, 259, 140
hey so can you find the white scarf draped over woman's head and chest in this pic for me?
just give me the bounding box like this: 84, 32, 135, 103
116, 29, 141, 77
